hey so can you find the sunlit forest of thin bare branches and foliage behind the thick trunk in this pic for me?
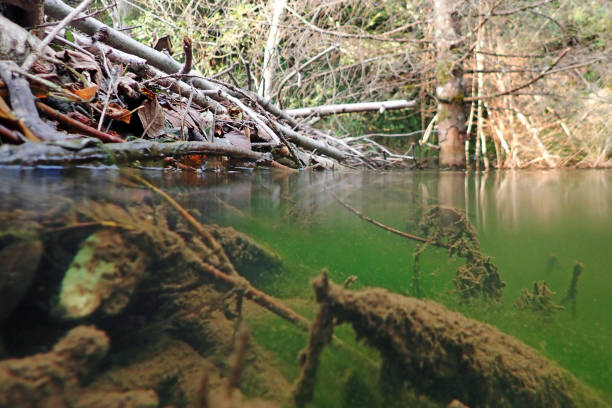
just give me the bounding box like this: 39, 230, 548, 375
69, 0, 612, 168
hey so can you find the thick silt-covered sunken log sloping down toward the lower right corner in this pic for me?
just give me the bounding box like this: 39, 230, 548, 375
313, 273, 605, 407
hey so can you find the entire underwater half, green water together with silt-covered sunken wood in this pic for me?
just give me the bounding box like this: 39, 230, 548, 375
0, 167, 612, 408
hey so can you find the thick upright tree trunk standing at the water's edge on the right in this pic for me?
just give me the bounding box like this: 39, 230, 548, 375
433, 0, 467, 168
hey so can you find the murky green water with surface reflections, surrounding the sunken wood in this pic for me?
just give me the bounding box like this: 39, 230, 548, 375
0, 168, 612, 406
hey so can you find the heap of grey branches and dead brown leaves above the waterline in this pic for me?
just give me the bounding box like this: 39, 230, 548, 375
0, 0, 408, 169
